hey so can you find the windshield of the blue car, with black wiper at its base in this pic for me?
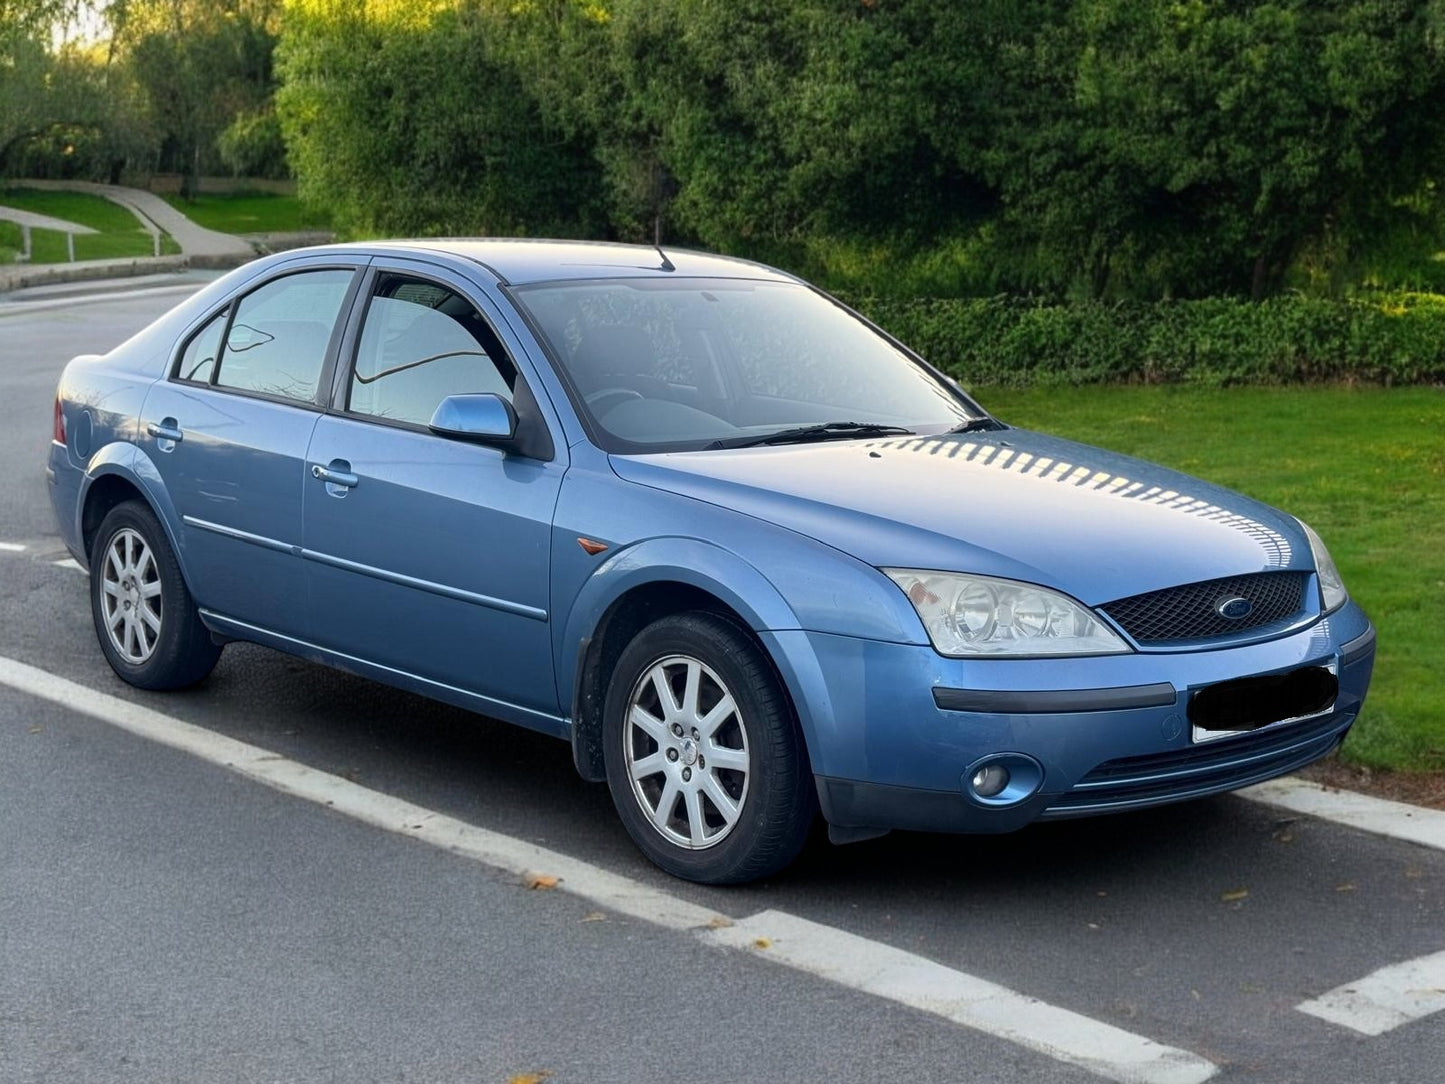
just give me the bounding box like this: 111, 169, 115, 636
514, 278, 983, 452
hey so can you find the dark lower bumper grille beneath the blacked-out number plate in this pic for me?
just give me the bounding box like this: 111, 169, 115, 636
1043, 714, 1354, 817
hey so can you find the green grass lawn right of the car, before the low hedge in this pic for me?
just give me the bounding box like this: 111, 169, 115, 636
975, 387, 1445, 772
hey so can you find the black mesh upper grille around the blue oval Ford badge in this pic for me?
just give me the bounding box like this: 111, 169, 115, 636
1100, 572, 1309, 645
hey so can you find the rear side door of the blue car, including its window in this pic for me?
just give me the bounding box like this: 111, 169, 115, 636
137, 260, 360, 637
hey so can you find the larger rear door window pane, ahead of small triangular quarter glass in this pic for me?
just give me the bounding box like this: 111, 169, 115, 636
215, 270, 353, 402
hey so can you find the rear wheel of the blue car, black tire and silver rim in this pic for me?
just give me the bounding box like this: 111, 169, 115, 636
91, 500, 221, 689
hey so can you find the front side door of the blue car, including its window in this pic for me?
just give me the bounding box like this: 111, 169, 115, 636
302, 264, 565, 728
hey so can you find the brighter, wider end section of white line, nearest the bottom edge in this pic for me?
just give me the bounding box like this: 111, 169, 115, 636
701, 911, 1218, 1084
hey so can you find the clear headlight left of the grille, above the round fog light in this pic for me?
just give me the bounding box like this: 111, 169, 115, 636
883, 568, 1130, 656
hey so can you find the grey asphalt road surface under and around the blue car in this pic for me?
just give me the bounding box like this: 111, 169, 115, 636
0, 284, 1445, 1084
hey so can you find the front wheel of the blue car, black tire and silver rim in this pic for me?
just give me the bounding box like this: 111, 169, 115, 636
603, 613, 816, 885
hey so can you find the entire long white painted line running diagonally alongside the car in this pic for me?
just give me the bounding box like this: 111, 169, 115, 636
0, 656, 1217, 1084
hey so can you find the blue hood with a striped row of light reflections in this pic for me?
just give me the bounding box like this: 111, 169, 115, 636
613, 429, 1312, 606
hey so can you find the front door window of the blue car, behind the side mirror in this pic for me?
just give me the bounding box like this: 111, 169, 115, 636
348, 276, 516, 425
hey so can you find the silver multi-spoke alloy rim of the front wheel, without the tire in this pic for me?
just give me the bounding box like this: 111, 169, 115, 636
623, 655, 750, 850
